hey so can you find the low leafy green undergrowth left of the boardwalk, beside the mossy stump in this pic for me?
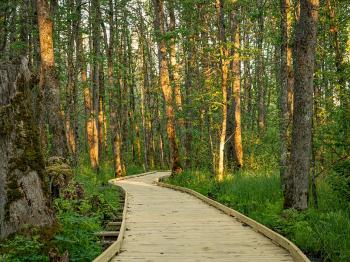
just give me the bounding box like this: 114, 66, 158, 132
0, 164, 123, 262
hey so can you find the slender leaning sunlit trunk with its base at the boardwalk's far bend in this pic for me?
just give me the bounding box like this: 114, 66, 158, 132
153, 0, 182, 174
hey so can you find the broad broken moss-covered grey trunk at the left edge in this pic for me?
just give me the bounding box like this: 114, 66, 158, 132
0, 58, 54, 239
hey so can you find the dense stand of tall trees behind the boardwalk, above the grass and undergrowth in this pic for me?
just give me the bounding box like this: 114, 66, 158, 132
0, 0, 350, 239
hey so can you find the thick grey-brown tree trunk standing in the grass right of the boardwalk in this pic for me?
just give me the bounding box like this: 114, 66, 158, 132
284, 0, 319, 210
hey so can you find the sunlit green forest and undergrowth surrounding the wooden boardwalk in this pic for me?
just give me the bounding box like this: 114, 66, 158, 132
0, 0, 350, 262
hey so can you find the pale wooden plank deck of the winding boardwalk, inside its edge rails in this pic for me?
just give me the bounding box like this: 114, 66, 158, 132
112, 172, 293, 262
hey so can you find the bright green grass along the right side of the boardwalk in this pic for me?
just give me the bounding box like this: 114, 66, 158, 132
168, 170, 350, 262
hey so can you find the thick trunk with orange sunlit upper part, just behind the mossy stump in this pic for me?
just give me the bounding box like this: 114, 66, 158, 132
36, 0, 68, 158
